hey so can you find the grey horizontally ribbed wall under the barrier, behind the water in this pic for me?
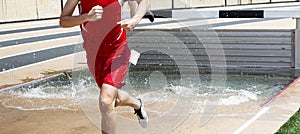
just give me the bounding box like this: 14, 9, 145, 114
128, 29, 295, 76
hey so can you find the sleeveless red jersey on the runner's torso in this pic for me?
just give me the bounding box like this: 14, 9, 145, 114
81, 0, 126, 55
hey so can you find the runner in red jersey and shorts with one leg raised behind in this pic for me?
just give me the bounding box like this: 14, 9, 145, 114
60, 0, 149, 134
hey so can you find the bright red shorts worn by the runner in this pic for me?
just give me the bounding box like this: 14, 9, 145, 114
84, 32, 130, 89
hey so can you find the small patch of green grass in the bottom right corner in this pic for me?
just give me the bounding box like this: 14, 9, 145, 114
276, 109, 300, 134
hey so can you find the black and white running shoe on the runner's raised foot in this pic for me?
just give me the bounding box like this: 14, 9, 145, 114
134, 99, 149, 128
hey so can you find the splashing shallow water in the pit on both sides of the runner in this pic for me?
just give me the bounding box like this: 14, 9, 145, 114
0, 71, 292, 113
